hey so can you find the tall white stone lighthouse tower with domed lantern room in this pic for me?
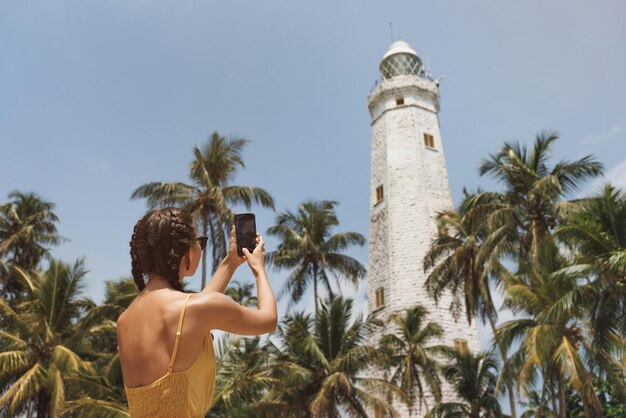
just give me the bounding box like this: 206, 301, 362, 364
367, 41, 480, 417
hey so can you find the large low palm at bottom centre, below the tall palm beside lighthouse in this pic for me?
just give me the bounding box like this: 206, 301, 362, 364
266, 296, 407, 418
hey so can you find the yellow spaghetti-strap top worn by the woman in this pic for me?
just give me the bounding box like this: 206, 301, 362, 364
118, 293, 215, 418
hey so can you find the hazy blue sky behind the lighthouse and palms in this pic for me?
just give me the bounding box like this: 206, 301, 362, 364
0, 0, 626, 408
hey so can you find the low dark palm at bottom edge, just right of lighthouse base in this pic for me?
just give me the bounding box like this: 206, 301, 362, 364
426, 348, 505, 418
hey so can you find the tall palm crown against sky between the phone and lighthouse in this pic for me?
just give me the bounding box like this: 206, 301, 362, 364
265, 200, 366, 313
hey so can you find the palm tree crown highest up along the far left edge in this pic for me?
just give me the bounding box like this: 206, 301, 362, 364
0, 190, 66, 303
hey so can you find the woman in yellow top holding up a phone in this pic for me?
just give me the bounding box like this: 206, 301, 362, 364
117, 207, 277, 418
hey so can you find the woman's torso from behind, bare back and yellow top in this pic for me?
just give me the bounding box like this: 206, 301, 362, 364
118, 290, 215, 417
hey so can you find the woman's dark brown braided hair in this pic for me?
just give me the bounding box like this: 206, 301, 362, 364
130, 207, 197, 292
